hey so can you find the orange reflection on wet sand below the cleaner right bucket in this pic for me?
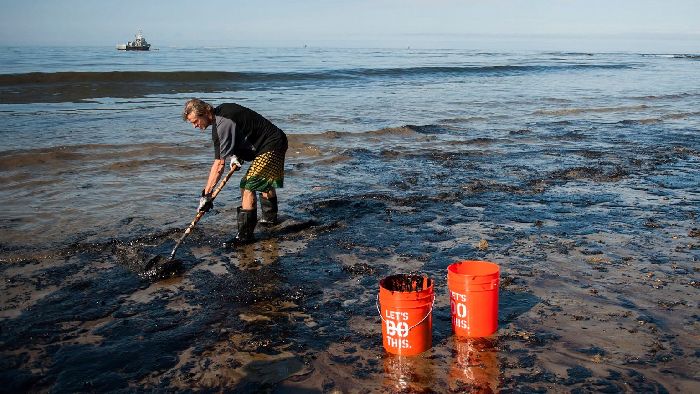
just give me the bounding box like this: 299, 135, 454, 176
449, 337, 500, 393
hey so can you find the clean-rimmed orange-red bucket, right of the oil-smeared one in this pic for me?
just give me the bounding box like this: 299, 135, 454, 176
447, 261, 500, 337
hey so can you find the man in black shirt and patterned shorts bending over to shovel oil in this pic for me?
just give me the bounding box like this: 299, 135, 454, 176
182, 99, 287, 247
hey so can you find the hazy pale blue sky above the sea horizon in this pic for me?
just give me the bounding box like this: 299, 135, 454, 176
0, 0, 700, 53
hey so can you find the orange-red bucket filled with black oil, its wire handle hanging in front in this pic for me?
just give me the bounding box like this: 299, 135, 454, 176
377, 274, 435, 356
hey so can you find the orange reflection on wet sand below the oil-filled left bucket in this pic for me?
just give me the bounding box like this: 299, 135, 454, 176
384, 353, 435, 393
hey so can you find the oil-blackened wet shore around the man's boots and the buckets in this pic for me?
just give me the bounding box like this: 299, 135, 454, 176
0, 127, 700, 392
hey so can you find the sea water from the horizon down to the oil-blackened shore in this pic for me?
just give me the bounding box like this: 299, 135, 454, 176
0, 47, 700, 243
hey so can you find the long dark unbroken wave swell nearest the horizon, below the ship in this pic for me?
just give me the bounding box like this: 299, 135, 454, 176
0, 63, 632, 104
